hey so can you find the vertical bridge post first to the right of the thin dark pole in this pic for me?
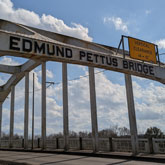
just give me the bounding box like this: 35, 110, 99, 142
41, 61, 46, 150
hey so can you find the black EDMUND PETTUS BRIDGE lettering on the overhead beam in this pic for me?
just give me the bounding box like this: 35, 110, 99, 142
9, 36, 154, 76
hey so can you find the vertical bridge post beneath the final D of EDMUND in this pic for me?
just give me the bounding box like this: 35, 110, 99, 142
62, 63, 69, 151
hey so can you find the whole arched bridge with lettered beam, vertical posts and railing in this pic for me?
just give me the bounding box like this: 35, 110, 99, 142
0, 20, 165, 155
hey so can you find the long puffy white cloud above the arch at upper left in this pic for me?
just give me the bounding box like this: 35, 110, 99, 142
0, 0, 92, 41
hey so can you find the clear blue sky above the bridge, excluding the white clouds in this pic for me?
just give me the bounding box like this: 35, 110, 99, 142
13, 0, 165, 50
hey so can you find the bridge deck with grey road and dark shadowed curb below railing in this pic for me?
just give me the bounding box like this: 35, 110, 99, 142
0, 150, 165, 165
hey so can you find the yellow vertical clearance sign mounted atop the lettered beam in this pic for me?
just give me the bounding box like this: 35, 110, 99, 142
128, 37, 156, 63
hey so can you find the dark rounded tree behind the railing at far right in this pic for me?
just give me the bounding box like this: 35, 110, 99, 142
145, 127, 164, 138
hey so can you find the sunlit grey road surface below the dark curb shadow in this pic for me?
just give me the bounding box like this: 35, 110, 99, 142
0, 151, 165, 165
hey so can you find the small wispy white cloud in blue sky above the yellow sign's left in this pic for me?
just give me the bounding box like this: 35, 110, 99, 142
103, 17, 129, 33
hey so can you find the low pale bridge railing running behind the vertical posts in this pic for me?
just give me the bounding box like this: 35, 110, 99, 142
0, 137, 165, 153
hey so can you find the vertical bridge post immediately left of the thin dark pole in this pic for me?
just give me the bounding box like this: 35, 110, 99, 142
24, 72, 29, 149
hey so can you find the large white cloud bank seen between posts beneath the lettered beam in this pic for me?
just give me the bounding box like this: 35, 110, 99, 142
0, 65, 165, 134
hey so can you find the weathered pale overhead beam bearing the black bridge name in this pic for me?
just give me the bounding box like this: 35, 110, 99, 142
0, 27, 165, 83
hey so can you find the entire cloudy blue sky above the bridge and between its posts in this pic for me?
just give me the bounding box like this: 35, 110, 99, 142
0, 0, 165, 135
